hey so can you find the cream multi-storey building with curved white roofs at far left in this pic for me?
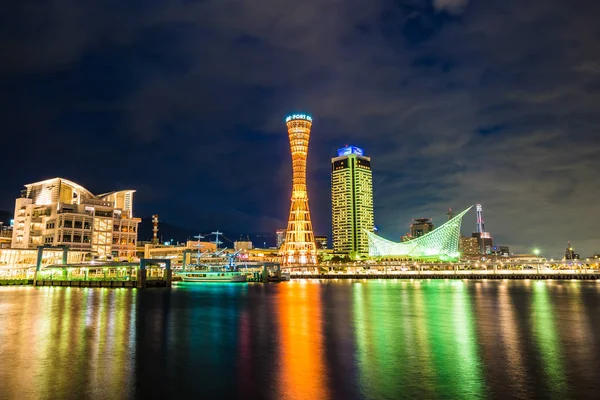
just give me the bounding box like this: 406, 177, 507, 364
11, 178, 141, 258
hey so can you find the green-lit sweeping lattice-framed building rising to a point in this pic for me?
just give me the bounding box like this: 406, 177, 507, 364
367, 207, 471, 261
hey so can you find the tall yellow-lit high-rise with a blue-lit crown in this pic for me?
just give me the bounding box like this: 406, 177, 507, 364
331, 146, 375, 258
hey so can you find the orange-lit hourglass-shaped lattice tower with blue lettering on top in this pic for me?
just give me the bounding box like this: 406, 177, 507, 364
280, 114, 317, 265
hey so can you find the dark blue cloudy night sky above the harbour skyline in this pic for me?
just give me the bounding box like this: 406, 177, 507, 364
0, 0, 600, 256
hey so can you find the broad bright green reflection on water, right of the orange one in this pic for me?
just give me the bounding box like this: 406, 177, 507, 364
353, 281, 485, 398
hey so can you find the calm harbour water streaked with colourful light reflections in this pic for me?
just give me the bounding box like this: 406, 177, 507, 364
0, 280, 600, 400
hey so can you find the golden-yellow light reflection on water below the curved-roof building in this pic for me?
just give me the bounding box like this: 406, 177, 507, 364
0, 288, 135, 398
